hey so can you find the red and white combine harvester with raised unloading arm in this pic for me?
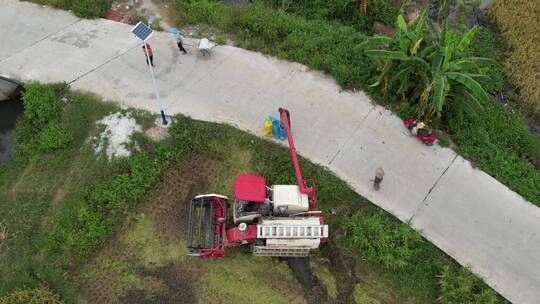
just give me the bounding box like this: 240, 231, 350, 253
187, 108, 328, 258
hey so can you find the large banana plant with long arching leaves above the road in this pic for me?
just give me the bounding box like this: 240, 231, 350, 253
358, 10, 488, 119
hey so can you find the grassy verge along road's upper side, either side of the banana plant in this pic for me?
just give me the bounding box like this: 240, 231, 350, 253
174, 0, 540, 205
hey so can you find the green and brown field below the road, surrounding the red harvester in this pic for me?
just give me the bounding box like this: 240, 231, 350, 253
0, 84, 505, 303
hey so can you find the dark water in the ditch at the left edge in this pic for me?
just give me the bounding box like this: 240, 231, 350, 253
0, 94, 24, 164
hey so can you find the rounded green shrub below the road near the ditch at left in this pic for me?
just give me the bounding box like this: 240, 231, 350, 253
23, 82, 62, 129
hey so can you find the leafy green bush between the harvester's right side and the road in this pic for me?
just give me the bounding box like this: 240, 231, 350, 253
343, 211, 422, 269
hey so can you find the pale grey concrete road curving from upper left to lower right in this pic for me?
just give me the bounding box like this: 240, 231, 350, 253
0, 0, 540, 304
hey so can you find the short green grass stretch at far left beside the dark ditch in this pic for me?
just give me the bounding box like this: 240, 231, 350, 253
0, 89, 114, 294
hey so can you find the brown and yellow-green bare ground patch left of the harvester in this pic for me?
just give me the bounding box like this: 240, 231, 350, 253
74, 156, 219, 303
